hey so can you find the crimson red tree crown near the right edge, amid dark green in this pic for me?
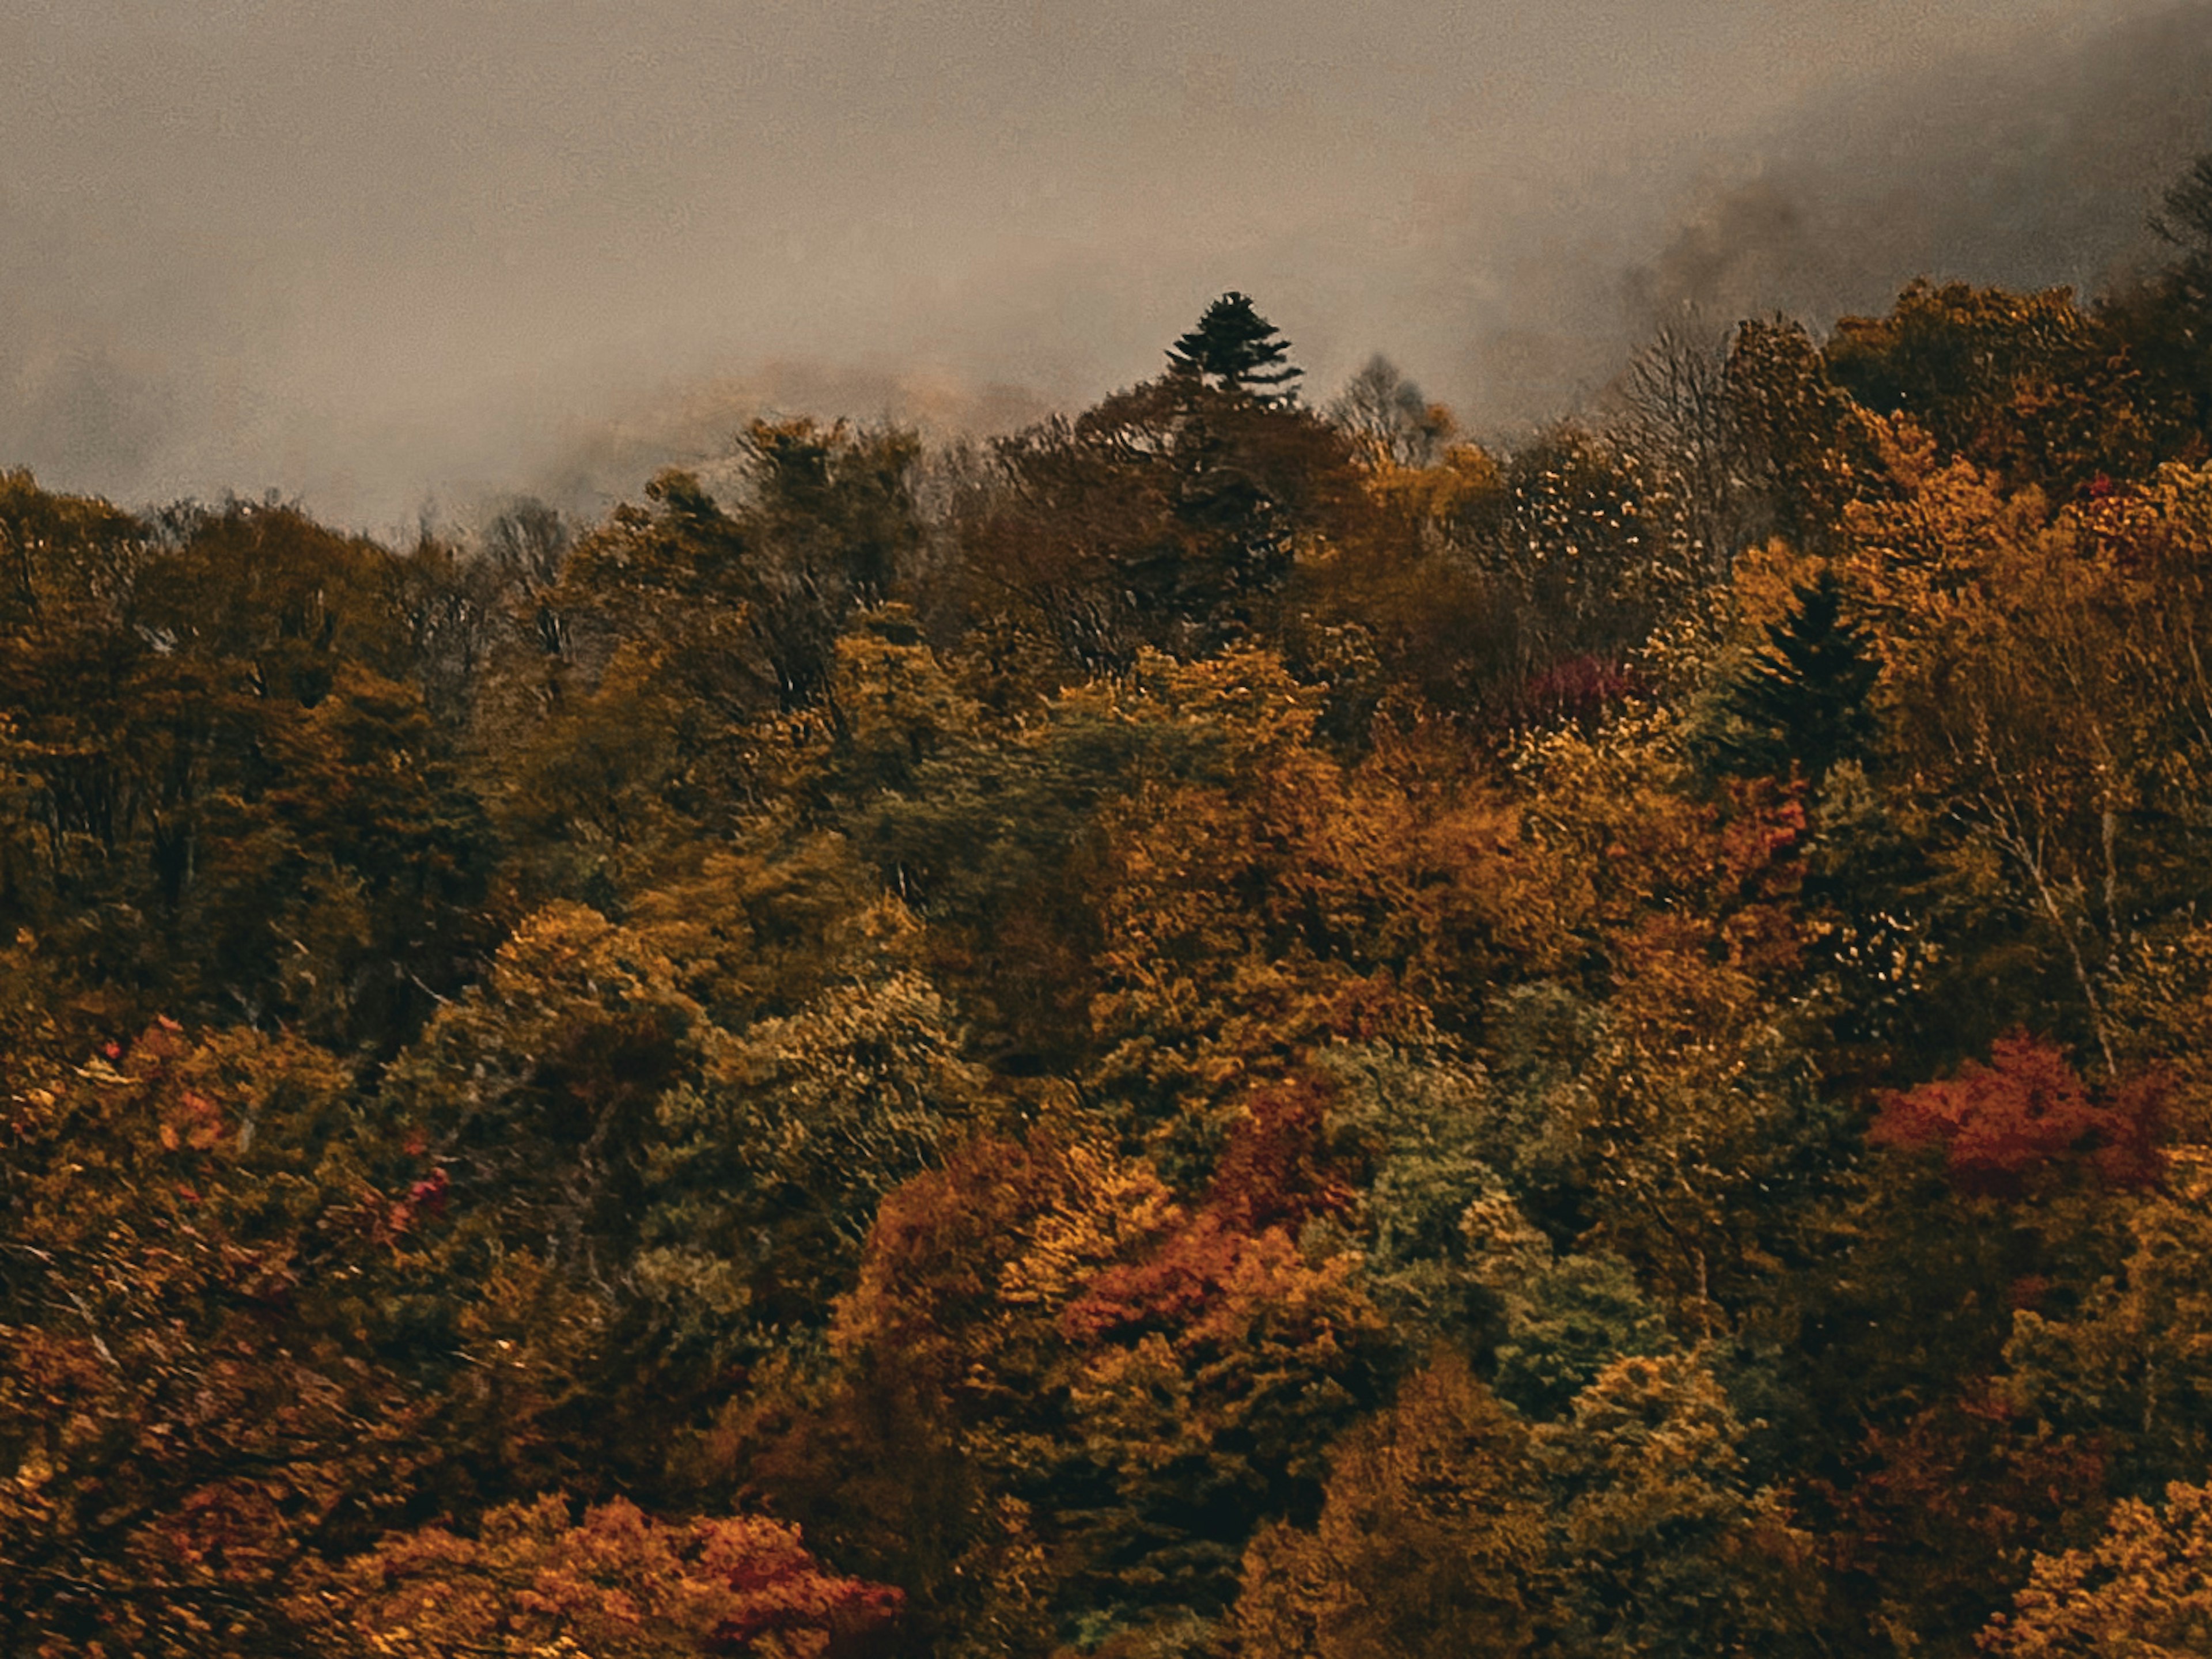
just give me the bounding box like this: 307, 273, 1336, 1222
1869, 1033, 2165, 1199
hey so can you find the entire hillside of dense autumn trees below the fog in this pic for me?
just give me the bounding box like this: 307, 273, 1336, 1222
13, 172, 2212, 1659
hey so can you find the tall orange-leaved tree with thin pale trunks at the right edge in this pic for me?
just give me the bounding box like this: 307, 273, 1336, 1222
1840, 449, 2212, 1064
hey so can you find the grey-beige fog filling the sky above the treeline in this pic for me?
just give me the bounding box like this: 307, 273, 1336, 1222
0, 0, 2212, 529
